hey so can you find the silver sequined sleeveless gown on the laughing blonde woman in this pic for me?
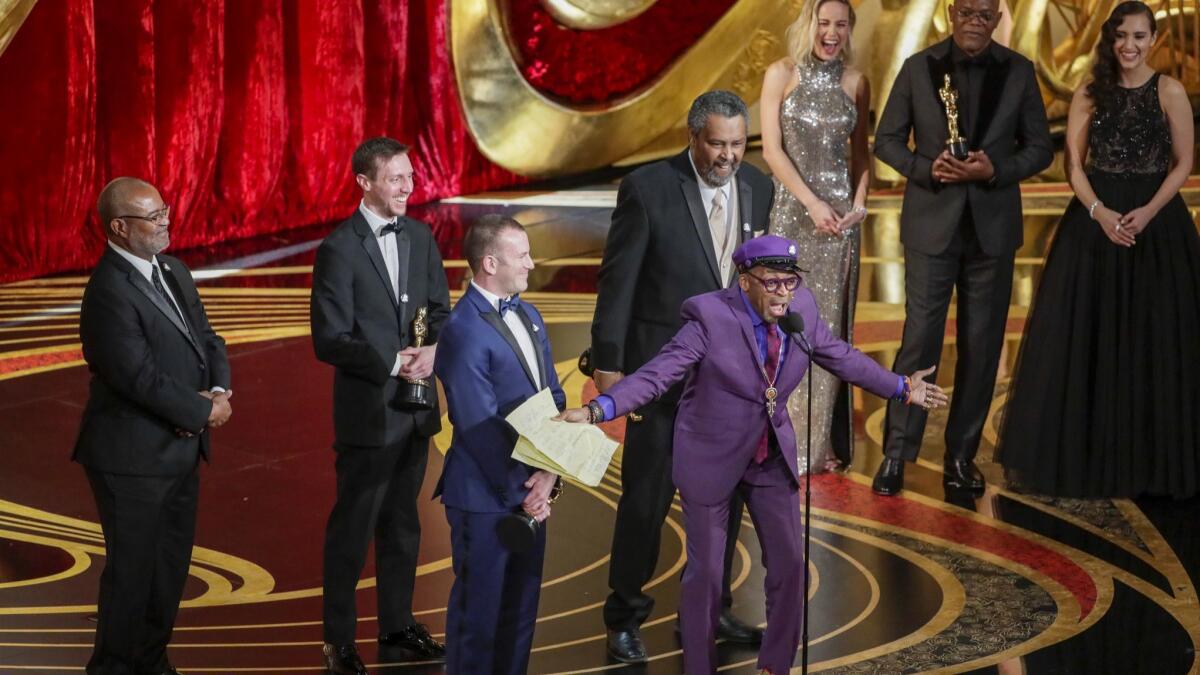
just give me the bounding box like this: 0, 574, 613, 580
770, 59, 862, 472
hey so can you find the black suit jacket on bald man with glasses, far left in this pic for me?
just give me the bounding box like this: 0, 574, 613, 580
72, 246, 230, 476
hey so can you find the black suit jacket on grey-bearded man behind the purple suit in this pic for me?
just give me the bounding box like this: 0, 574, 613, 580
592, 150, 775, 400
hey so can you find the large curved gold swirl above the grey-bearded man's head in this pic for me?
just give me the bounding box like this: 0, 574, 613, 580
450, 0, 799, 175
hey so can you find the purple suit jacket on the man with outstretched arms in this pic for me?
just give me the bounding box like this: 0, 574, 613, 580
606, 286, 896, 504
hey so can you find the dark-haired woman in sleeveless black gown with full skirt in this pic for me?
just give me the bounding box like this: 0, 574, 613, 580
997, 2, 1200, 497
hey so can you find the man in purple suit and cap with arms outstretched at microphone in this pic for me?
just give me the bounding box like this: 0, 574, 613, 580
560, 237, 947, 674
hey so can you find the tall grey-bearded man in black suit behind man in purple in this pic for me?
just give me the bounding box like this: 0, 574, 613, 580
592, 90, 774, 663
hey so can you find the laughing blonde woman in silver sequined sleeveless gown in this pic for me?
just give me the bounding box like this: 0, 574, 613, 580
761, 0, 870, 472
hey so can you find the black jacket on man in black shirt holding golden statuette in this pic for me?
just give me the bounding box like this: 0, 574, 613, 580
875, 40, 1054, 256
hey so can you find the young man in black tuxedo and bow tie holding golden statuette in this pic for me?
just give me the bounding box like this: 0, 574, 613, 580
311, 138, 450, 675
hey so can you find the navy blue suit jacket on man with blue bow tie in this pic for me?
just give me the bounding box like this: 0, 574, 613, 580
433, 286, 566, 513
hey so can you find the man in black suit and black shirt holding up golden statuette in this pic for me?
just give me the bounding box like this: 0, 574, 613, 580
872, 0, 1054, 495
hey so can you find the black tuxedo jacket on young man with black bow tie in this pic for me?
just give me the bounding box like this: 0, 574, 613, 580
311, 209, 450, 447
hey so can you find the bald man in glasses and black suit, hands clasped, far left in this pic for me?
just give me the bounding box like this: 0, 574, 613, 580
73, 178, 233, 675
